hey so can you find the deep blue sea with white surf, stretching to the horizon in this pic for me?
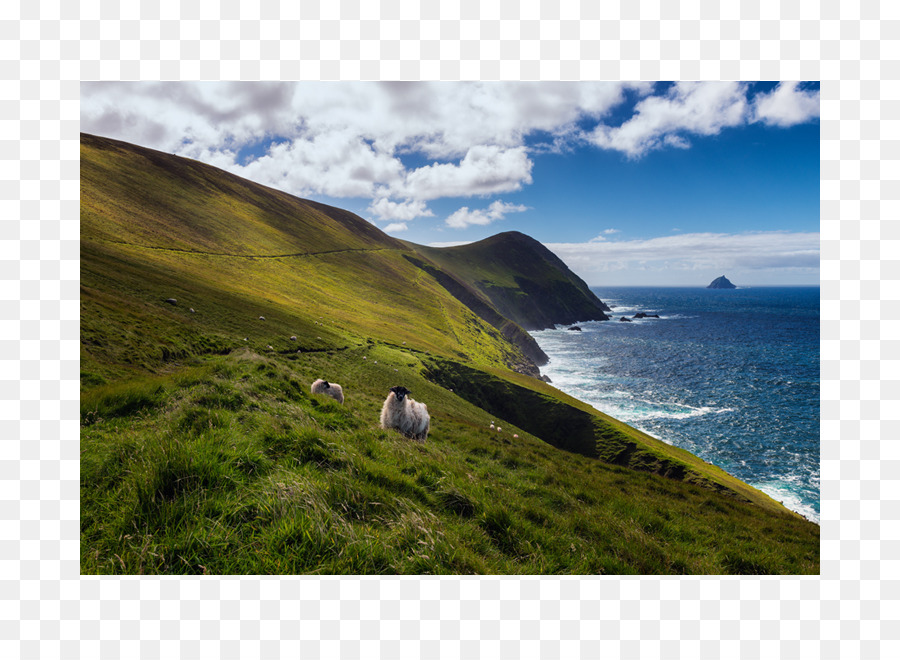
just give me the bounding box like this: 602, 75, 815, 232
531, 287, 819, 522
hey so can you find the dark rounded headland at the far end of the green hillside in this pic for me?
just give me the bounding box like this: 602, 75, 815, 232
408, 231, 610, 330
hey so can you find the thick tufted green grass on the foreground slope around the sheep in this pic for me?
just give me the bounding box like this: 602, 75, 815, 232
81, 346, 818, 574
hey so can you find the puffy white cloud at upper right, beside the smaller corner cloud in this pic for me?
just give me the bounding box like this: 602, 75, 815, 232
587, 82, 747, 158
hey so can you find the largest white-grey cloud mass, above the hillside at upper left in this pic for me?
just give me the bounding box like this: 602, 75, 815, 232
81, 82, 636, 206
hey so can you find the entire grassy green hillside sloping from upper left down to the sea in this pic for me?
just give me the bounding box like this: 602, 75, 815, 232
81, 136, 819, 574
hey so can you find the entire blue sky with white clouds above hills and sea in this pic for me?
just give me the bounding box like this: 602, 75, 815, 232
81, 82, 819, 286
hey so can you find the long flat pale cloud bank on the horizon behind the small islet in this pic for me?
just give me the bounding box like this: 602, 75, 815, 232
547, 232, 820, 282
